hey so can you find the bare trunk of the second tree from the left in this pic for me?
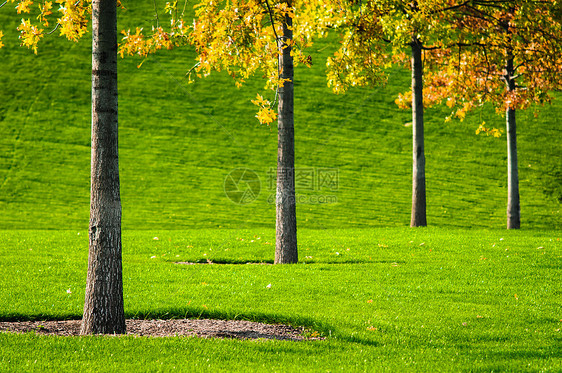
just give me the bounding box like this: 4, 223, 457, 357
275, 2, 298, 264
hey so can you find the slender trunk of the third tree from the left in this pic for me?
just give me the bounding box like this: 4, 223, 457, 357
410, 37, 427, 227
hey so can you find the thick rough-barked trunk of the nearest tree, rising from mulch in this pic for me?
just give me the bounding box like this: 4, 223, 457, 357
80, 0, 125, 334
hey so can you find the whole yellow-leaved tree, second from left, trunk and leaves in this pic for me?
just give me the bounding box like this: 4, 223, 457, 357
121, 0, 319, 264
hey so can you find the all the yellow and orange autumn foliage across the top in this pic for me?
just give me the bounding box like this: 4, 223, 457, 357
4, 0, 562, 119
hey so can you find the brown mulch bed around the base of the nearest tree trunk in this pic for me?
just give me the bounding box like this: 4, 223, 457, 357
0, 319, 324, 341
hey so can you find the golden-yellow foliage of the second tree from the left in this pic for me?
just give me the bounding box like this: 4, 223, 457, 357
116, 0, 321, 124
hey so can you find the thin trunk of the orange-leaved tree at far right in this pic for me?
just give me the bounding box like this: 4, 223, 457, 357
505, 51, 521, 229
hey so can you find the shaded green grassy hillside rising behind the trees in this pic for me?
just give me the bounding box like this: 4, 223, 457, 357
0, 1, 562, 229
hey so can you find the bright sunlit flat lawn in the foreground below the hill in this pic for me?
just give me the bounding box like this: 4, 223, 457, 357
0, 228, 562, 371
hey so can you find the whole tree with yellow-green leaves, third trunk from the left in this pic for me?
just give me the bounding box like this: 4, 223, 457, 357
320, 0, 468, 227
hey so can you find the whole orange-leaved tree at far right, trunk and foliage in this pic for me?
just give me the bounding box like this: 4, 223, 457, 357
424, 0, 562, 229
